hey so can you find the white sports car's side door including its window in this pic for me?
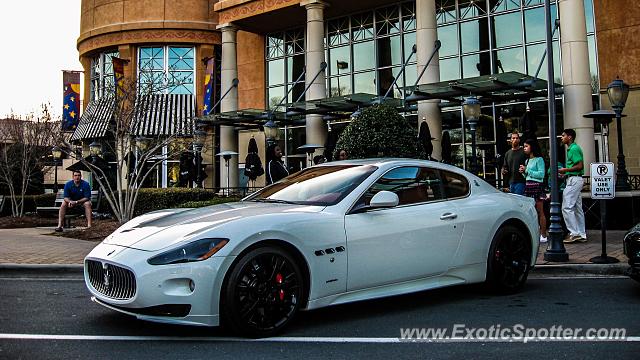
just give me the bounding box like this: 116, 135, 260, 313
345, 166, 463, 290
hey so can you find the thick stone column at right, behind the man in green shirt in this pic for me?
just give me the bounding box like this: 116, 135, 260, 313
558, 0, 596, 174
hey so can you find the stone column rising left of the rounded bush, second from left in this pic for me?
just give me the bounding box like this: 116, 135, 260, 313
300, 0, 327, 149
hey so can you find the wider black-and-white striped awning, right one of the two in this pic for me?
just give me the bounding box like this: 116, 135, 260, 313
131, 94, 195, 136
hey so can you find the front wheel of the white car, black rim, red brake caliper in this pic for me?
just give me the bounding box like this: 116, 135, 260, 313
221, 246, 305, 337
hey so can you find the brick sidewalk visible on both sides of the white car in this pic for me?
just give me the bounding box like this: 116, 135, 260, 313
0, 227, 627, 274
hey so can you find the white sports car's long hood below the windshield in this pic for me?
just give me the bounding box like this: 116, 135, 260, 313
104, 201, 324, 251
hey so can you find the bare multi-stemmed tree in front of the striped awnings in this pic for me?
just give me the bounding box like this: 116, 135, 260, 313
63, 75, 199, 223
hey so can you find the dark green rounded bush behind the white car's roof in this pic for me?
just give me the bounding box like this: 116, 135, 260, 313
334, 105, 420, 159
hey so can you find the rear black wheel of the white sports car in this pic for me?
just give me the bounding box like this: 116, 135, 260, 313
487, 225, 531, 294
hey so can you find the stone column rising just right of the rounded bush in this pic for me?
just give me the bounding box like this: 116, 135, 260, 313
416, 0, 442, 160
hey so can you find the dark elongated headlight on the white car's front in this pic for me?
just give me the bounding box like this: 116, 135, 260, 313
147, 239, 229, 265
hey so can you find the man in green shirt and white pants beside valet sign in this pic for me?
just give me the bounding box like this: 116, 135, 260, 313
558, 129, 587, 243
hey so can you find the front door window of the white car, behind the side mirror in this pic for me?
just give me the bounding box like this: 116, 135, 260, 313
361, 166, 444, 205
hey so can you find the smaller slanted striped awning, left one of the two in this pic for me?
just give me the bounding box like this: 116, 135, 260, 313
71, 97, 115, 141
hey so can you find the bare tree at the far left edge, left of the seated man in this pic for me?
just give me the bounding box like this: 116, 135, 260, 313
0, 105, 61, 217
